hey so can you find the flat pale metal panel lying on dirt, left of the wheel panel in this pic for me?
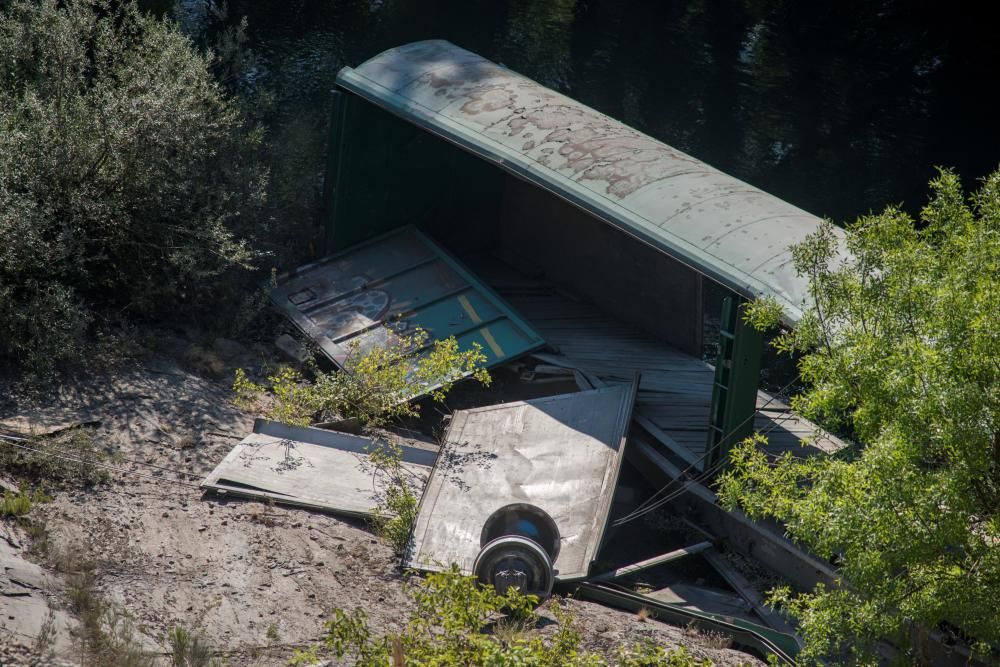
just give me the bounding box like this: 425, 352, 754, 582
201, 419, 437, 517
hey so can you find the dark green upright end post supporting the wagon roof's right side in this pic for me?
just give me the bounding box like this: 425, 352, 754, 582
705, 296, 764, 469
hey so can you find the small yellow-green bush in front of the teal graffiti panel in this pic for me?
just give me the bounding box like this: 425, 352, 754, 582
233, 329, 490, 426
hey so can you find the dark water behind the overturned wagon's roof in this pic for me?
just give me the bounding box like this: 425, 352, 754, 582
164, 0, 1000, 220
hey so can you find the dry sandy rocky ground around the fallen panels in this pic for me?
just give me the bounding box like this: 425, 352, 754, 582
0, 334, 761, 666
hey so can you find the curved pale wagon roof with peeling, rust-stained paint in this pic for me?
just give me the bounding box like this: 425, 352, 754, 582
337, 40, 844, 324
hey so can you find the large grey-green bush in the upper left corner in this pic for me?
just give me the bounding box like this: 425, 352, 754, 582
0, 0, 266, 367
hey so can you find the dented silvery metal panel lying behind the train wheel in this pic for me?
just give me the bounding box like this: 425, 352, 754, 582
404, 382, 637, 581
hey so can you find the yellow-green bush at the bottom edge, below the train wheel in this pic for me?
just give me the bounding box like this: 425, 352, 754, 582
291, 565, 712, 667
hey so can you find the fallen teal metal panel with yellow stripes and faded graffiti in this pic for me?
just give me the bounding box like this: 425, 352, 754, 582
271, 227, 545, 367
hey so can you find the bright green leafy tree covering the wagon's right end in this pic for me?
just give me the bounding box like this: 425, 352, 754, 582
721, 170, 1000, 663
